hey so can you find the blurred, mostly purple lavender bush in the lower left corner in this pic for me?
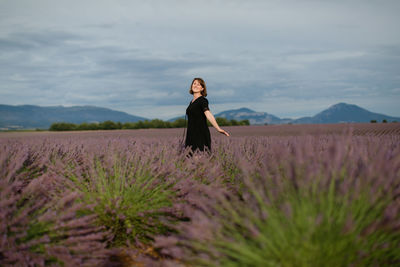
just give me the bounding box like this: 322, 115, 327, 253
0, 146, 112, 266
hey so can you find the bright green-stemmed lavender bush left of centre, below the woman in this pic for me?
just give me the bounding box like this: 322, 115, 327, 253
53, 151, 183, 246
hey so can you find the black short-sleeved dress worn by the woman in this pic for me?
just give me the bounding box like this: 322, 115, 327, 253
185, 96, 211, 151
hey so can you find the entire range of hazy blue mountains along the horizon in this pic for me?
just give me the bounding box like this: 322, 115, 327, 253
0, 103, 400, 130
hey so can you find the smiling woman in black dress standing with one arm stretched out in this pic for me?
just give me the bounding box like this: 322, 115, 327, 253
185, 78, 229, 151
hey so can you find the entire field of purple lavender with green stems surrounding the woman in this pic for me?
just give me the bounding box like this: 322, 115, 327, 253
0, 123, 400, 266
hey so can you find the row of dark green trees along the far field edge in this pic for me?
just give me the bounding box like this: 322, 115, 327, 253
49, 117, 250, 131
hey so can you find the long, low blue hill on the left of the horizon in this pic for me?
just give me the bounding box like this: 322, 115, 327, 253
0, 105, 146, 129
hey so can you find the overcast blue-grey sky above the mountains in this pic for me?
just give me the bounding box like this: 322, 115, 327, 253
0, 0, 400, 119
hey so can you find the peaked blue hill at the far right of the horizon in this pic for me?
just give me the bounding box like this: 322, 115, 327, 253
291, 103, 400, 124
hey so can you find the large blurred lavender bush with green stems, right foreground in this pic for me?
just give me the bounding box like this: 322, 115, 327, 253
156, 136, 400, 266
